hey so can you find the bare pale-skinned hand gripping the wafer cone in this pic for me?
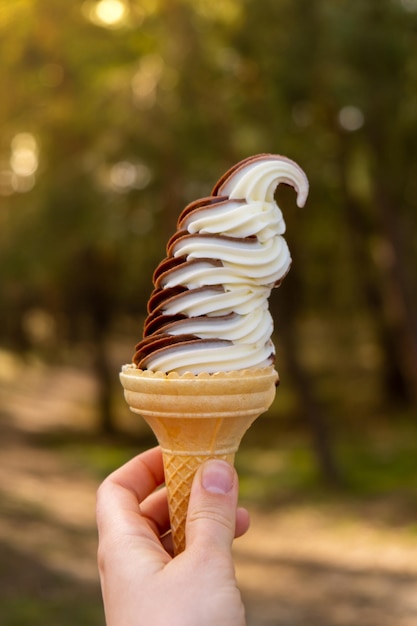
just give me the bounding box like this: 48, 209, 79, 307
97, 448, 249, 626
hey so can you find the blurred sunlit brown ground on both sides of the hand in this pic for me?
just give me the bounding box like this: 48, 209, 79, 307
0, 353, 417, 626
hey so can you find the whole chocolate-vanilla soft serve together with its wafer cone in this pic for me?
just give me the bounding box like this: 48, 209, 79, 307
120, 154, 308, 554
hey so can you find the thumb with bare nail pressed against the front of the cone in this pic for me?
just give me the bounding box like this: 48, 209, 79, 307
186, 459, 238, 550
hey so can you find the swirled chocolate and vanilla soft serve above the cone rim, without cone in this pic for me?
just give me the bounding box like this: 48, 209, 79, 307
133, 154, 308, 374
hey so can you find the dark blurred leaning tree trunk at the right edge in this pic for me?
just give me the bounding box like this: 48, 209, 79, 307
339, 137, 417, 407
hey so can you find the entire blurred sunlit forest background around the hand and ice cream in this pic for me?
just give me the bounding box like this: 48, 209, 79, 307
0, 0, 417, 626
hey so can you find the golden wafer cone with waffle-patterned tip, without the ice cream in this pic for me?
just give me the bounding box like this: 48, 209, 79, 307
120, 365, 278, 554
